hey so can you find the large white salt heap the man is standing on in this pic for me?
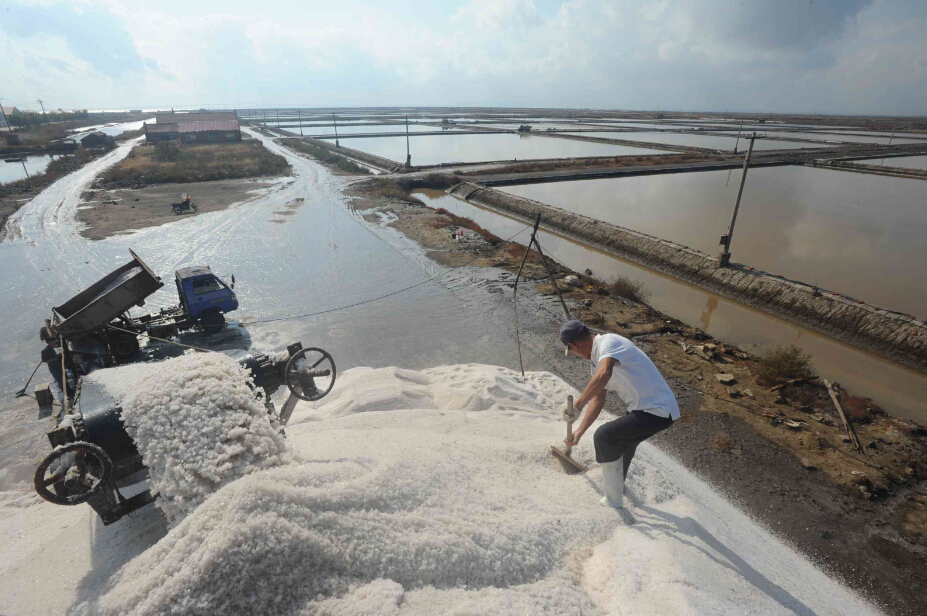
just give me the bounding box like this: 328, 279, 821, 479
73, 360, 878, 616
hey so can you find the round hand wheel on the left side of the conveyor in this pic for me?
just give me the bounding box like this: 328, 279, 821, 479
33, 441, 113, 505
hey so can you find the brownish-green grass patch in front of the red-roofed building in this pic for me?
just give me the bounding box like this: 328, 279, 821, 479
98, 141, 289, 186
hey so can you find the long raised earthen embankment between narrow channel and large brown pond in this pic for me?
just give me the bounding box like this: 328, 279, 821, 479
449, 182, 927, 372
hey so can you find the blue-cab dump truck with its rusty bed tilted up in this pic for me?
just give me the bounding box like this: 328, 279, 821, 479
48, 250, 238, 374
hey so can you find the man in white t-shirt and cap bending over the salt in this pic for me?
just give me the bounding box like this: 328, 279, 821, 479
560, 320, 679, 509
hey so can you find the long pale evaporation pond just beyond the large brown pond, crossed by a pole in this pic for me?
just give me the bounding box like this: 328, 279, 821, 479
330, 133, 663, 165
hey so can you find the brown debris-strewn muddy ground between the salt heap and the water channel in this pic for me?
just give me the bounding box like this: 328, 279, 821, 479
347, 180, 927, 615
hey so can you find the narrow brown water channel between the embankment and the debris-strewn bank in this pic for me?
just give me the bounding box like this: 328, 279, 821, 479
415, 190, 927, 423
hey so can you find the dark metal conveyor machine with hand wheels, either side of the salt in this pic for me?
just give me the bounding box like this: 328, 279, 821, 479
34, 342, 336, 525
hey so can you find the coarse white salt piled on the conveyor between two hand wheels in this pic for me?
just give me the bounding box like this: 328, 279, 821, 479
119, 353, 289, 524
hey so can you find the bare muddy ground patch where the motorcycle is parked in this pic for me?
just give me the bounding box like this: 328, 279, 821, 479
77, 178, 292, 240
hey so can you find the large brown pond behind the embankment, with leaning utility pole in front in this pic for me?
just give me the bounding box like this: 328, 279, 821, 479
500, 167, 927, 318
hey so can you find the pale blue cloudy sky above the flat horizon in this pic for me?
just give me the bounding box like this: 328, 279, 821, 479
0, 0, 927, 115
